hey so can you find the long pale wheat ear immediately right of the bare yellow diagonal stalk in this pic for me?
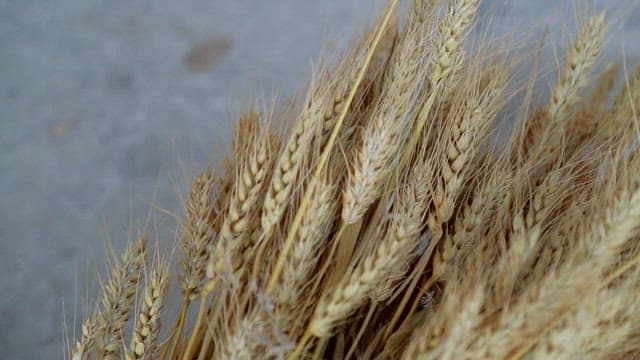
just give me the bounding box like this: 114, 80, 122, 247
336, 1, 428, 284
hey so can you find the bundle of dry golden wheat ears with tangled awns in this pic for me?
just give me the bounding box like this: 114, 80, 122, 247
68, 0, 640, 360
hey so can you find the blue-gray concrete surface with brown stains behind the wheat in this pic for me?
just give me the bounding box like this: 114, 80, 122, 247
0, 0, 640, 359
